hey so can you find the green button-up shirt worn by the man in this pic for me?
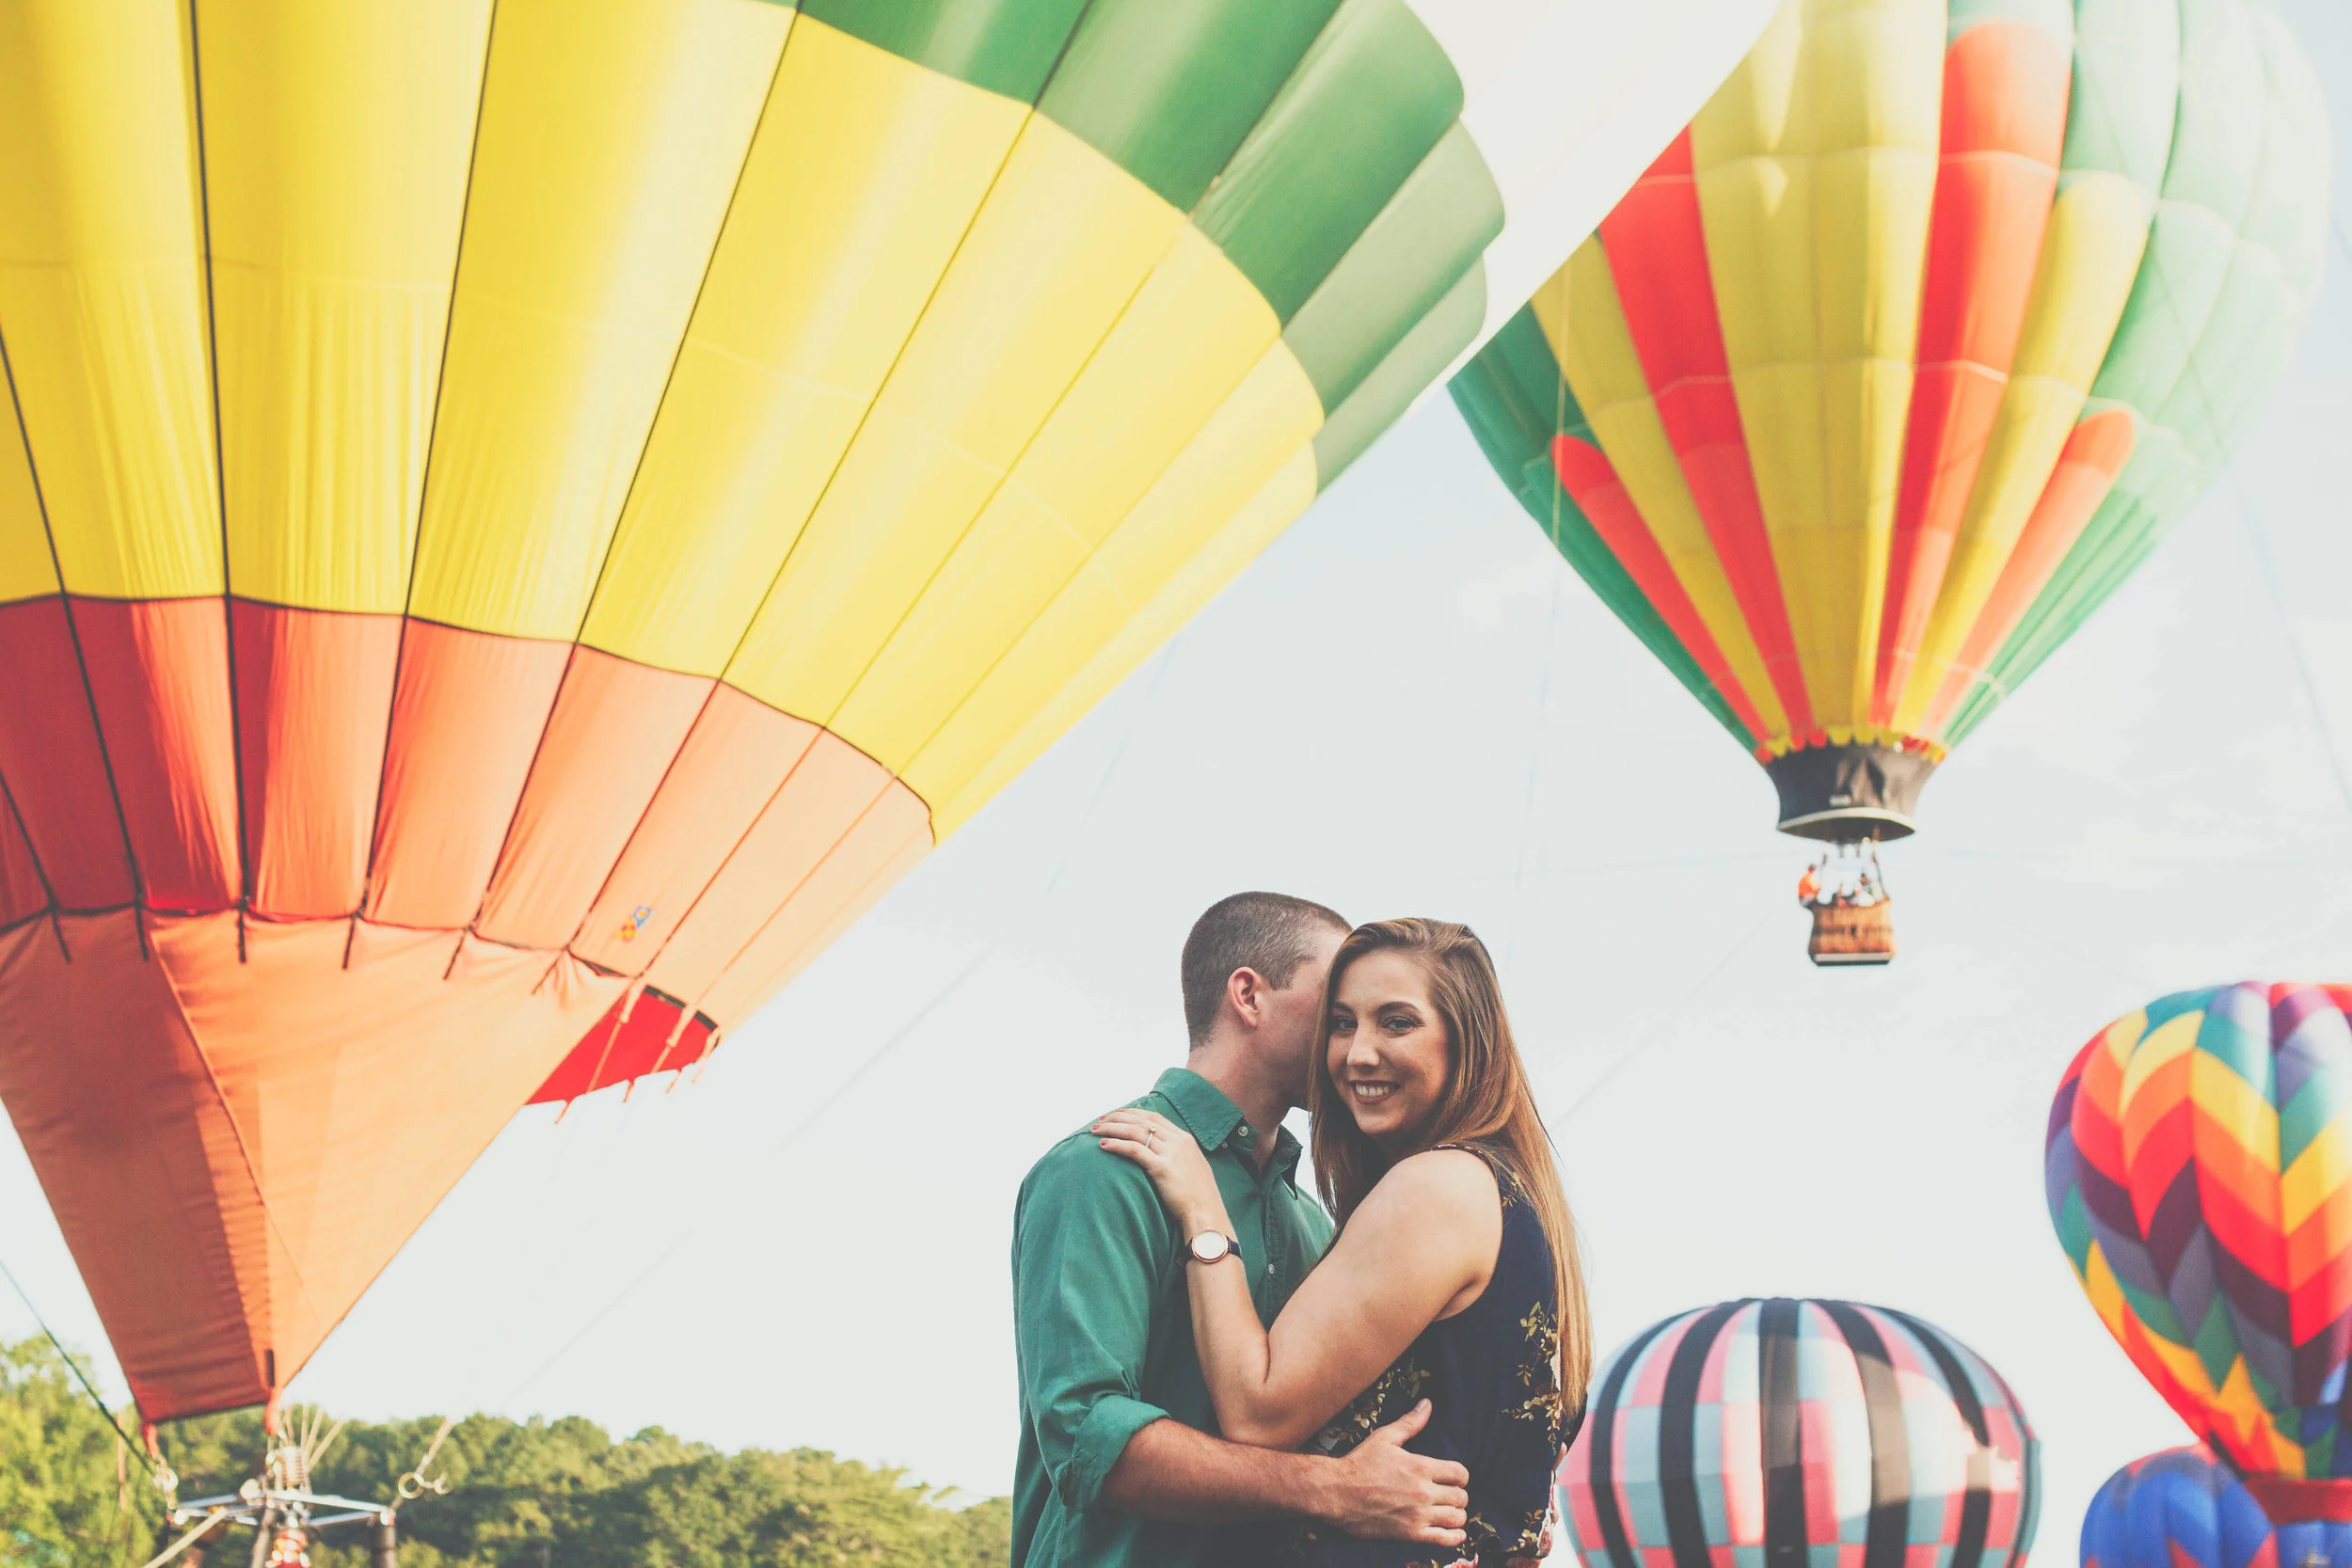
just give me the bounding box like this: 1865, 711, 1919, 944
1014, 1068, 1331, 1568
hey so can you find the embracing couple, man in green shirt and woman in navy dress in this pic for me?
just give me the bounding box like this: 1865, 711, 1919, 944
1011, 894, 1593, 1568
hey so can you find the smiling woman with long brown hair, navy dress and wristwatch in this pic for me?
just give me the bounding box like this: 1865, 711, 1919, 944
1094, 919, 1593, 1568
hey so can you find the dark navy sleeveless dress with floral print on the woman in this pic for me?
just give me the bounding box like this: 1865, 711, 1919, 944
1270, 1143, 1571, 1568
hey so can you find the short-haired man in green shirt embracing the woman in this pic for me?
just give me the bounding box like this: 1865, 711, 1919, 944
1011, 894, 1468, 1568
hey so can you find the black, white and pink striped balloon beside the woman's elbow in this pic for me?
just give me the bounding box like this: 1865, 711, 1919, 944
1560, 1298, 2042, 1568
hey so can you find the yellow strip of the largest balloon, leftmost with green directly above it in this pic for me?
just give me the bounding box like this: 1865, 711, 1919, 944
586, 16, 1028, 674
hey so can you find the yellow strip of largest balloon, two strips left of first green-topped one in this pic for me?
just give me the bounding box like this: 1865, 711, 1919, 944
196, 0, 489, 613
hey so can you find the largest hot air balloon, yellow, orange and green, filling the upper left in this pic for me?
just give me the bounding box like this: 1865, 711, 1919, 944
0, 0, 1764, 1420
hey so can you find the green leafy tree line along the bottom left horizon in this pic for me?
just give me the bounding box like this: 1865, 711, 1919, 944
0, 1340, 1011, 1568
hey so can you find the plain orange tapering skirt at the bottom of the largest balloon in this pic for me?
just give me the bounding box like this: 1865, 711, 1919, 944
0, 907, 626, 1420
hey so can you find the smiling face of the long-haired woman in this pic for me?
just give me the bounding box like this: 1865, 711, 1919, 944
1325, 952, 1454, 1154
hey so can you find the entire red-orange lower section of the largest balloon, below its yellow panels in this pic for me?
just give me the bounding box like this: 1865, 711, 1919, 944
0, 597, 931, 1420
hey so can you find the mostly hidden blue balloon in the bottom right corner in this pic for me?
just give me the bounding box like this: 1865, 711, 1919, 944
2082, 1446, 2352, 1568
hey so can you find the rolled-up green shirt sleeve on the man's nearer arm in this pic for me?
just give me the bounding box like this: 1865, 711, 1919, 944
1014, 1140, 1174, 1512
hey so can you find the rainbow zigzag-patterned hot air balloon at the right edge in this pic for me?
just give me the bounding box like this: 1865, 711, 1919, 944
2044, 983, 2352, 1526
